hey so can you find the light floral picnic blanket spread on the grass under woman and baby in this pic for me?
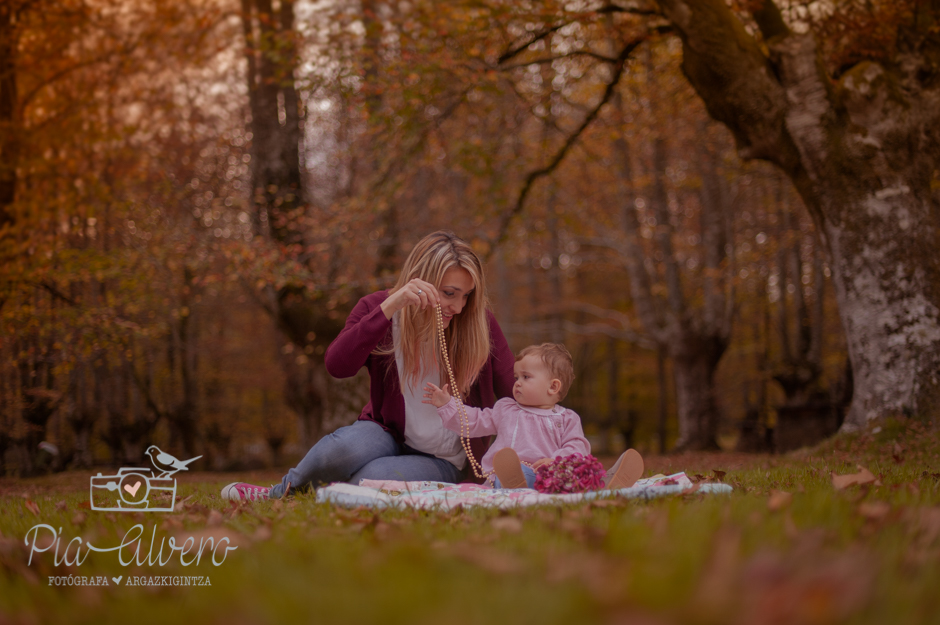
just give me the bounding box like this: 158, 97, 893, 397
317, 473, 732, 511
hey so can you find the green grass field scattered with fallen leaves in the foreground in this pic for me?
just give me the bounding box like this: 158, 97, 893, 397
0, 420, 940, 625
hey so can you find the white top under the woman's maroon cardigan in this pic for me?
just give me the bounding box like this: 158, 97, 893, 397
392, 313, 467, 469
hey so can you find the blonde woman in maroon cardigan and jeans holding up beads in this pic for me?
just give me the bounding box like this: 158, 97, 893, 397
222, 231, 515, 501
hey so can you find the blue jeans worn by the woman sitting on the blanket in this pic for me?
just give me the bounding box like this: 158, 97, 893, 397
269, 421, 464, 499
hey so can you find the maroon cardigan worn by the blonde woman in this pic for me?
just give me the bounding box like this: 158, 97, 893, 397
325, 291, 515, 477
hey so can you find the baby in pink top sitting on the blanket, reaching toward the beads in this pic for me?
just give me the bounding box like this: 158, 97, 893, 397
423, 343, 643, 488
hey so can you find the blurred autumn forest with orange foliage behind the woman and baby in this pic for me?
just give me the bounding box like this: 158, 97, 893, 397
0, 0, 940, 475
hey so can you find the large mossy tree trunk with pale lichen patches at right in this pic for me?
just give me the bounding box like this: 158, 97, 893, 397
660, 0, 940, 430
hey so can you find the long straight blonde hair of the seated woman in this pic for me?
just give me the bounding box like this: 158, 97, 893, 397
374, 230, 490, 397
